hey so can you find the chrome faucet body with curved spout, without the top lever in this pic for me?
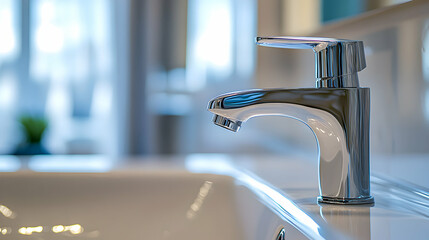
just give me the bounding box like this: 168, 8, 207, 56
208, 87, 373, 204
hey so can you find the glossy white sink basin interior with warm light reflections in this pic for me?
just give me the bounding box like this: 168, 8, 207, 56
0, 171, 306, 240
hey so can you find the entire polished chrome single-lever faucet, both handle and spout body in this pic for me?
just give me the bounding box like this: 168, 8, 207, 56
208, 37, 374, 204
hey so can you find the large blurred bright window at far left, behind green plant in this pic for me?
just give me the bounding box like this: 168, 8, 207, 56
0, 0, 117, 154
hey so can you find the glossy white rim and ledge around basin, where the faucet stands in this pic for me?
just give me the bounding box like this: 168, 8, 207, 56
0, 154, 429, 239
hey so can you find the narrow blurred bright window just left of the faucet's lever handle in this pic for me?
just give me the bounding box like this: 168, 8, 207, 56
186, 0, 257, 91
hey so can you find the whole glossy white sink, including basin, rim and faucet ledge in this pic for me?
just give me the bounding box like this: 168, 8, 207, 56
0, 155, 429, 240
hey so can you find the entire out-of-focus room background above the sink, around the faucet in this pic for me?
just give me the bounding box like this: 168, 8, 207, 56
0, 0, 429, 163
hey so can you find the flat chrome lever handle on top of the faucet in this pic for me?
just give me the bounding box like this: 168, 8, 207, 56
256, 36, 366, 88
